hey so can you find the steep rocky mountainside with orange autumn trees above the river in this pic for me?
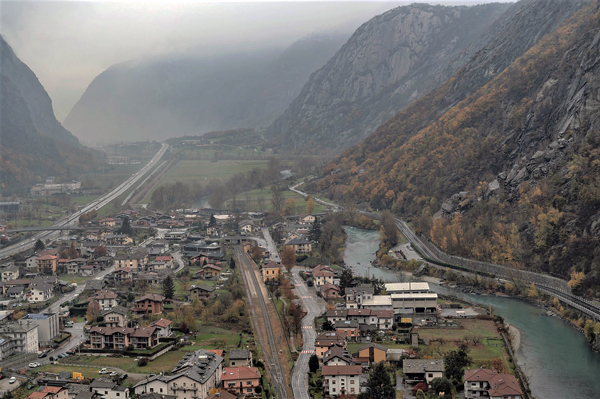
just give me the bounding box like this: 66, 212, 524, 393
310, 0, 600, 294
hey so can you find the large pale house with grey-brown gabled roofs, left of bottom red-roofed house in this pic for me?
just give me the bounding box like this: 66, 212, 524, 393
133, 349, 223, 399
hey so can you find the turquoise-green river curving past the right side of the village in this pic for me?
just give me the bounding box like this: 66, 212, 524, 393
344, 227, 600, 399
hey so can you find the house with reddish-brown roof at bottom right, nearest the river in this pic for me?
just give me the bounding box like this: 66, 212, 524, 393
464, 369, 523, 399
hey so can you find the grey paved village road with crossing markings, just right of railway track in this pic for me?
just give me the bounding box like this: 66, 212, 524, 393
292, 267, 325, 399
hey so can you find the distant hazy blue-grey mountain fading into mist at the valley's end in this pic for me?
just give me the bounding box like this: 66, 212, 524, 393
64, 35, 347, 142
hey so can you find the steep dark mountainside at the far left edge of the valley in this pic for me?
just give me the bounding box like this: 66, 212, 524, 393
0, 37, 94, 195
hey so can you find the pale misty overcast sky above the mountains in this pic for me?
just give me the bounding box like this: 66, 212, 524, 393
0, 1, 510, 121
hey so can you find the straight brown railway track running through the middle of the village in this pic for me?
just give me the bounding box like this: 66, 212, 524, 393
235, 246, 288, 399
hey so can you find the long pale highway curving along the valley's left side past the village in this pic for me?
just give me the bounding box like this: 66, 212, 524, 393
0, 144, 169, 260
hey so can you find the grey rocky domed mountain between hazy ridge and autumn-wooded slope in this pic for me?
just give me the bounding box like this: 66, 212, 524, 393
266, 3, 510, 156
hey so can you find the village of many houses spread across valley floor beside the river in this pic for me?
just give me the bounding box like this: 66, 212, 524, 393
0, 202, 524, 399
